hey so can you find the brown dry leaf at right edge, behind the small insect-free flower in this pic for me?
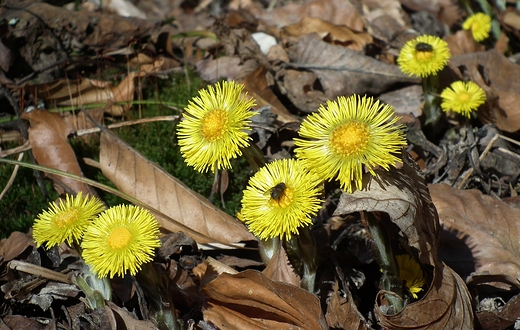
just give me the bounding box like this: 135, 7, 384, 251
449, 49, 520, 132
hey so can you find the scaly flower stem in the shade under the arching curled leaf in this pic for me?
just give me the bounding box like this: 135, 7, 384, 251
364, 212, 403, 313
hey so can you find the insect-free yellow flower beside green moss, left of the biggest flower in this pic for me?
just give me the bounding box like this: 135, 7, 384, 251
177, 81, 256, 172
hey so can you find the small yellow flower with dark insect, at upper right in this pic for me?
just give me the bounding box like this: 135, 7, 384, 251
397, 35, 451, 78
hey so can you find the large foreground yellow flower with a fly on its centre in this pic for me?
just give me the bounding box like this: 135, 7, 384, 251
239, 159, 322, 240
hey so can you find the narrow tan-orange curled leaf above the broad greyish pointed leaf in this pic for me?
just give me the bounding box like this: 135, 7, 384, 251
282, 17, 372, 51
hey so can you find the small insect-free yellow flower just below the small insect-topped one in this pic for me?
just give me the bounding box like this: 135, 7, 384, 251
441, 81, 486, 118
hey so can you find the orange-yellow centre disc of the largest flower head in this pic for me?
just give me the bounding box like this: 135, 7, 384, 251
330, 121, 370, 156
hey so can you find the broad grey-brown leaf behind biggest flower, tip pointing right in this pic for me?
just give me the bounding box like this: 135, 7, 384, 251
277, 35, 419, 112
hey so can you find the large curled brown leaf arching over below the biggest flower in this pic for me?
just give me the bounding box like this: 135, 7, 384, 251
335, 152, 473, 329
